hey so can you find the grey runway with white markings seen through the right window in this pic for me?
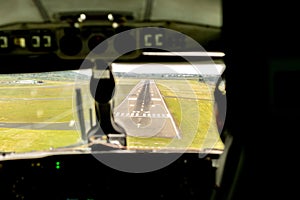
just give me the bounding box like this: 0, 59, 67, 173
114, 80, 181, 139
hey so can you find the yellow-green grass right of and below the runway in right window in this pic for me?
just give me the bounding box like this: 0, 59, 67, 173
128, 80, 224, 150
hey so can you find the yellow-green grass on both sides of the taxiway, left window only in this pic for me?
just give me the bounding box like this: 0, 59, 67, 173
0, 77, 87, 152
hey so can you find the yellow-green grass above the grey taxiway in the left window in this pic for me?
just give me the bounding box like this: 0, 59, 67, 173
0, 82, 89, 123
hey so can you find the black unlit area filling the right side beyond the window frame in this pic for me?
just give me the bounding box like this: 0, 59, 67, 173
212, 0, 300, 200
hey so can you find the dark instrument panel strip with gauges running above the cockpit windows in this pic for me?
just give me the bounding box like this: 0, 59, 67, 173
0, 21, 220, 60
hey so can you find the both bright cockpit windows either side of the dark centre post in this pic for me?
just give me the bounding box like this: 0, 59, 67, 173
0, 62, 225, 153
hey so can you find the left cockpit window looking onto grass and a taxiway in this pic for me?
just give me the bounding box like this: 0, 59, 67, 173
0, 71, 95, 153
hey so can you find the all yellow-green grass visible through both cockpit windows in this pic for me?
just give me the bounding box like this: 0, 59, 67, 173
0, 75, 223, 152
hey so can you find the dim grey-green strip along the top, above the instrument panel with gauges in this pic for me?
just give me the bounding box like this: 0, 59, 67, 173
0, 0, 222, 27
